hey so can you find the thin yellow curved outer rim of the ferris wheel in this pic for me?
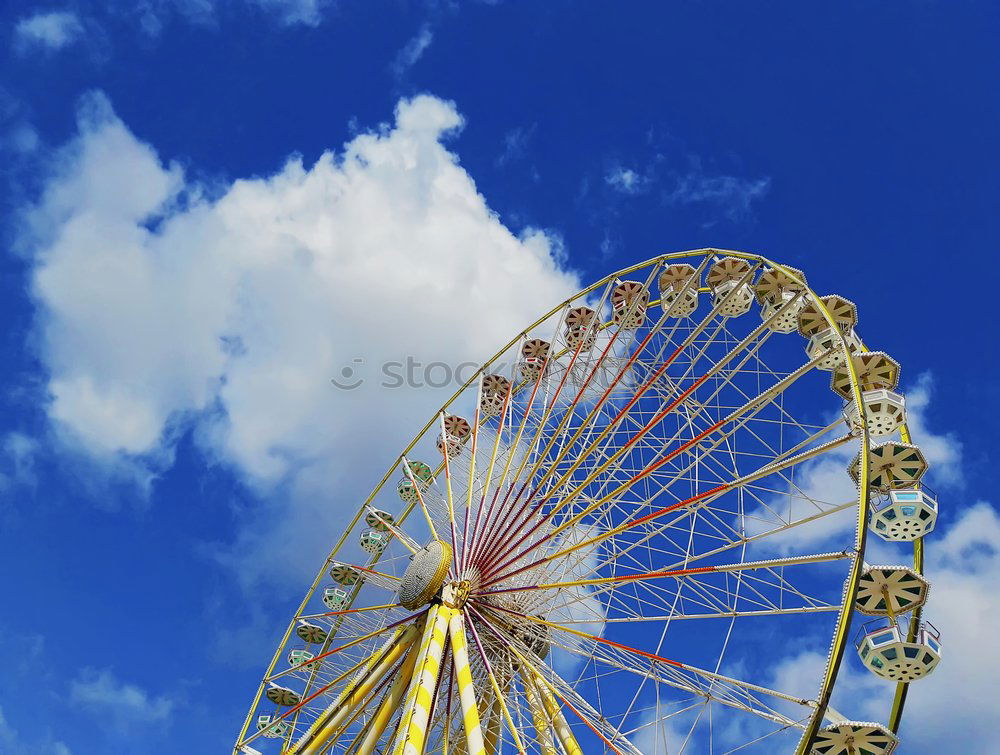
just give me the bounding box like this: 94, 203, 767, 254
233, 247, 900, 755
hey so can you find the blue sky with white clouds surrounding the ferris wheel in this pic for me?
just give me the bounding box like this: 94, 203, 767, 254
0, 0, 1000, 754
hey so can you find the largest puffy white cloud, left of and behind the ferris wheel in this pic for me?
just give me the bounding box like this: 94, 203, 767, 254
21, 90, 578, 580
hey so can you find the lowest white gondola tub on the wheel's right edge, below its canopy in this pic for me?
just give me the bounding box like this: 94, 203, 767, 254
855, 619, 941, 682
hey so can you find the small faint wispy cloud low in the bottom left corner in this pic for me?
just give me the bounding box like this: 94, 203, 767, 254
69, 669, 174, 730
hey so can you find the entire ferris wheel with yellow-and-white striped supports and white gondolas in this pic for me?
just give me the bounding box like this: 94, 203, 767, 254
234, 249, 941, 755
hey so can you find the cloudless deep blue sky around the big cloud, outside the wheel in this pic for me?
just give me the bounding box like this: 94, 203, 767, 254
0, 0, 1000, 753
